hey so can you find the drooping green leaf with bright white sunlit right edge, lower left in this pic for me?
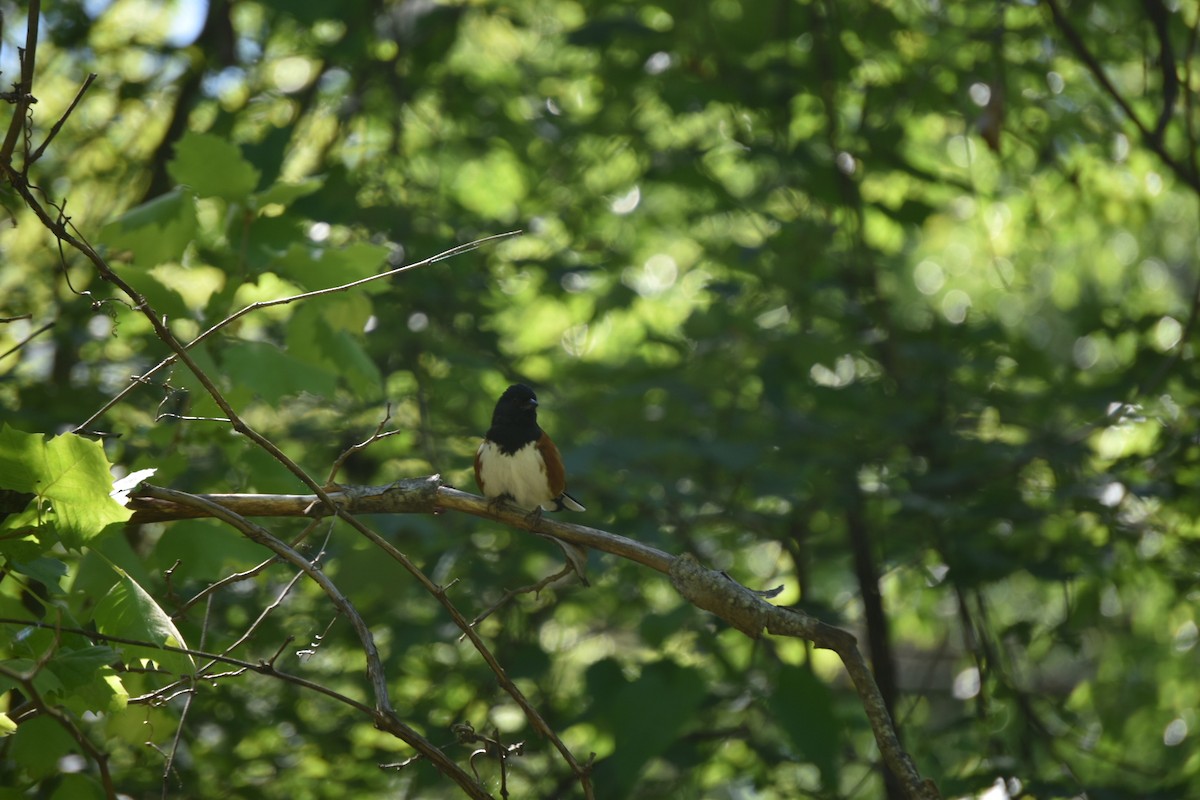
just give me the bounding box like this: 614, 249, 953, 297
96, 566, 196, 674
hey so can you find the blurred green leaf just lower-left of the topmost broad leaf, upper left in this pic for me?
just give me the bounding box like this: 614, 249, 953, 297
100, 188, 196, 269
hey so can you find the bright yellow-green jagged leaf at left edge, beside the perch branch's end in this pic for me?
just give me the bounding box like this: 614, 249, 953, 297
0, 426, 131, 548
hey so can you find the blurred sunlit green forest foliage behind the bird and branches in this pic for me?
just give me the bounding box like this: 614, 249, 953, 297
0, 0, 1200, 800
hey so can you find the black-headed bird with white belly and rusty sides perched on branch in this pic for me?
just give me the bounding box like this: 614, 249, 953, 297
475, 384, 587, 518
